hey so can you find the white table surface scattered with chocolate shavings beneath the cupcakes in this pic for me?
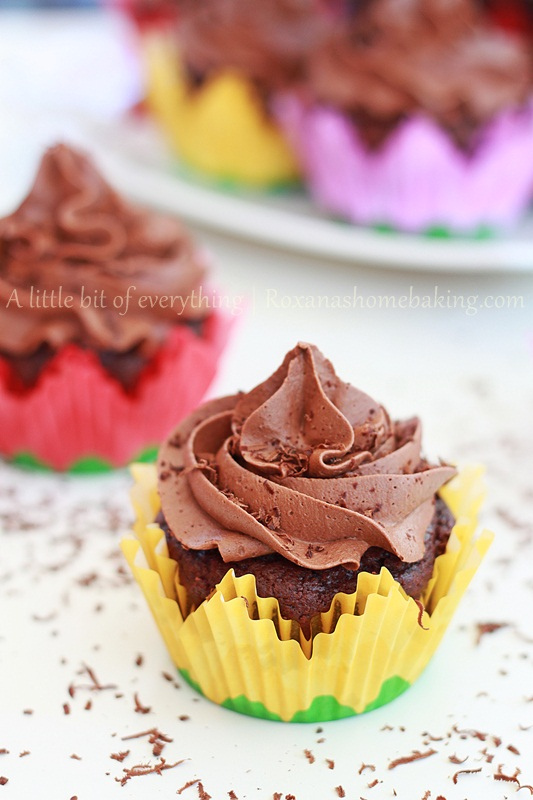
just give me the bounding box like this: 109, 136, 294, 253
0, 7, 533, 800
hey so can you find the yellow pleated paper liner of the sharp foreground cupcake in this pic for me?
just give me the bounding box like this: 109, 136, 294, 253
122, 464, 492, 722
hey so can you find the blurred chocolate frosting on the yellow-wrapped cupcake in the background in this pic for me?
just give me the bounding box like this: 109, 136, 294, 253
178, 0, 321, 91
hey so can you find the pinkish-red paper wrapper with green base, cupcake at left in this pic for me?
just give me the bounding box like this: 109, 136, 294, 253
0, 313, 230, 471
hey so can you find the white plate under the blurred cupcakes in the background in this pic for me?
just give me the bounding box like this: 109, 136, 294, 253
91, 112, 533, 273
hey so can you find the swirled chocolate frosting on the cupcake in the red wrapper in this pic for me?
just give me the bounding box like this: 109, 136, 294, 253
0, 144, 206, 356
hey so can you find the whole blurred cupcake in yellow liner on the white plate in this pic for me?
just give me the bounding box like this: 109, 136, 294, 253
132, 0, 322, 187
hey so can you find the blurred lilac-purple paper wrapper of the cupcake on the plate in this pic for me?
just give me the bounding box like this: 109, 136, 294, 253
275, 96, 533, 232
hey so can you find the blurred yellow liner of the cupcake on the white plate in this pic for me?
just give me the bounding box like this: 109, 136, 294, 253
142, 32, 298, 187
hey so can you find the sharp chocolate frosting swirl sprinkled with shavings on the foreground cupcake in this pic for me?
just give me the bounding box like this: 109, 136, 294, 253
158, 344, 455, 569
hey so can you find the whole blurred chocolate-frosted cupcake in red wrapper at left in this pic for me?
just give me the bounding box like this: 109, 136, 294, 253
0, 144, 233, 469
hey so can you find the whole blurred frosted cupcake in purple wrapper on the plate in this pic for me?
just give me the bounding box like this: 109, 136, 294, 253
278, 0, 533, 232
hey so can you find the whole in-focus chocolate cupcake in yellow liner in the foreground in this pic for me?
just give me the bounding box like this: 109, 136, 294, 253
124, 344, 488, 721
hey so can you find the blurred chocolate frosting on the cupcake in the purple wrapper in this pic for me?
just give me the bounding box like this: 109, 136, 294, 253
309, 0, 533, 145
